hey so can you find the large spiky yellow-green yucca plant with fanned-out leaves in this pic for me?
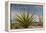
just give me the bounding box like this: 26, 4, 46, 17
16, 13, 34, 28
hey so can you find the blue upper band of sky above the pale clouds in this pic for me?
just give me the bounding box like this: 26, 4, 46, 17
10, 4, 43, 16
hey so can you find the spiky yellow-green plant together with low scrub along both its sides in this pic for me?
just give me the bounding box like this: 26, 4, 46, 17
10, 13, 43, 29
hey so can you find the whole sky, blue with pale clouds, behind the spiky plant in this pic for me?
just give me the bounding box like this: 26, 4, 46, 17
10, 4, 43, 22
